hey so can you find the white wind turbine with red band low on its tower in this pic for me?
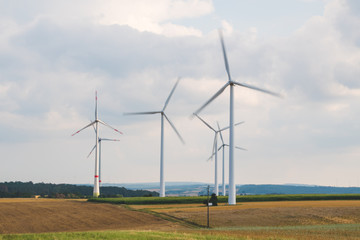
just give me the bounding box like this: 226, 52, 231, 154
71, 92, 122, 197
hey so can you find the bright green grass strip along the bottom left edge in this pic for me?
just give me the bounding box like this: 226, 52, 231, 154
0, 231, 243, 240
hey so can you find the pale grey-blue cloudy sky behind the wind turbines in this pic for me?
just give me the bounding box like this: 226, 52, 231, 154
0, 0, 360, 186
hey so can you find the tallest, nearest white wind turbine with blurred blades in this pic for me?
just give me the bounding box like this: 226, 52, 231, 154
193, 30, 280, 205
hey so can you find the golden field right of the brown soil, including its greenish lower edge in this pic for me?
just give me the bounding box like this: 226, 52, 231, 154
131, 200, 360, 240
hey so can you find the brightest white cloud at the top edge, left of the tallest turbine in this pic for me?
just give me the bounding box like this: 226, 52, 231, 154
95, 0, 214, 36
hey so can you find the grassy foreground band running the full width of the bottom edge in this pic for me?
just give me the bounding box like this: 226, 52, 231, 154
0, 224, 360, 240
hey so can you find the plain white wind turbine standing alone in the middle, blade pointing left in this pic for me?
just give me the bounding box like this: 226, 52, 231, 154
124, 78, 185, 197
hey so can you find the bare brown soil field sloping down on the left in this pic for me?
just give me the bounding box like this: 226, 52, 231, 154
0, 199, 183, 234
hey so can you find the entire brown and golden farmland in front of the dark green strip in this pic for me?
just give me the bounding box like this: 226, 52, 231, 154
0, 199, 360, 240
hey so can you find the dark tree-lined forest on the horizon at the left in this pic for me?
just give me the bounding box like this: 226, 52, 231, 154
0, 182, 159, 198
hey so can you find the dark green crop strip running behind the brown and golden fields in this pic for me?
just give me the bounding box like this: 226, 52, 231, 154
88, 194, 360, 205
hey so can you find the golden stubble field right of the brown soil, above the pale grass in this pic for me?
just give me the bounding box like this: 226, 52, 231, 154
132, 200, 360, 228
